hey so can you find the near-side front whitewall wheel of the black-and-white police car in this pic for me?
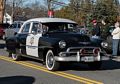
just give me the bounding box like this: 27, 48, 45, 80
46, 50, 60, 71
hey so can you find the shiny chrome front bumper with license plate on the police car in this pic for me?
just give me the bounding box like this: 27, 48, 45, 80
54, 52, 110, 62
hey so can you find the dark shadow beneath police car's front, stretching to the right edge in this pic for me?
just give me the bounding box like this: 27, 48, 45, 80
60, 60, 120, 71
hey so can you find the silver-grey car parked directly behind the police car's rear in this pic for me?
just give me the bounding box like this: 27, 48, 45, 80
5, 21, 23, 38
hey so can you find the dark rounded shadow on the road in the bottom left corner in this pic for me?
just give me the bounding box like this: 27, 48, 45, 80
0, 76, 35, 84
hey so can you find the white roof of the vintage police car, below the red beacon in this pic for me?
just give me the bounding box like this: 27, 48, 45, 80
26, 18, 77, 24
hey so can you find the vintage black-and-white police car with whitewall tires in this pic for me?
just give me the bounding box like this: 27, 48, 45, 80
6, 18, 108, 71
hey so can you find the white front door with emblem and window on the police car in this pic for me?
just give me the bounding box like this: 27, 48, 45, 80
26, 22, 42, 57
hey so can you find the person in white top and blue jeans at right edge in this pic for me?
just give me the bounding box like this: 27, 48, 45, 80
112, 22, 120, 58
